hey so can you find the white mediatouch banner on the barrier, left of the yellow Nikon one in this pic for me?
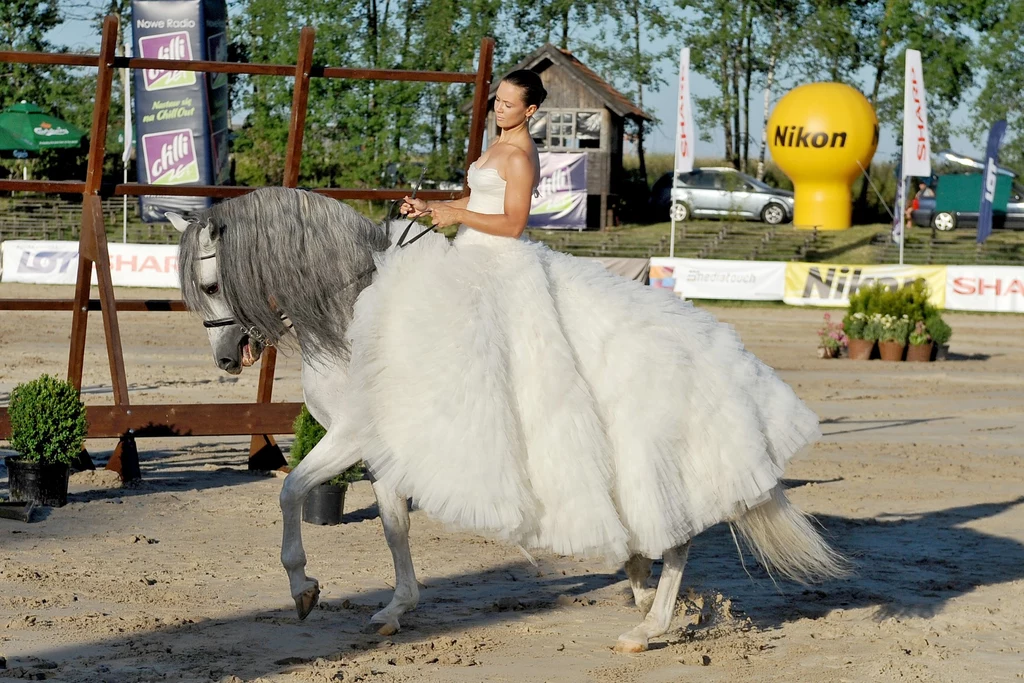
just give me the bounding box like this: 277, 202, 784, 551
650, 258, 785, 301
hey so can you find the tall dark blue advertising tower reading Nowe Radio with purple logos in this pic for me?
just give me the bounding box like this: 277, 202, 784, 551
132, 0, 228, 222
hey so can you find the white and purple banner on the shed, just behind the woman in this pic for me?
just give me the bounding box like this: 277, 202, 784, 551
527, 152, 587, 230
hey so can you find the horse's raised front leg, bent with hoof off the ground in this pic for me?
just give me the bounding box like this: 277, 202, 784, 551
281, 428, 359, 618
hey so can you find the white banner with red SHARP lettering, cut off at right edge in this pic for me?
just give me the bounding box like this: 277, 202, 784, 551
946, 265, 1024, 313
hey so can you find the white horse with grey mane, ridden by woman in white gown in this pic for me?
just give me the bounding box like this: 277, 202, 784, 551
174, 188, 846, 652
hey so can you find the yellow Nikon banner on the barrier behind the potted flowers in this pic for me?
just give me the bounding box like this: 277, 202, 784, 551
782, 261, 946, 308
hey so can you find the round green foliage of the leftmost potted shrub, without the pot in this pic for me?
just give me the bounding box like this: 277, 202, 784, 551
7, 375, 87, 465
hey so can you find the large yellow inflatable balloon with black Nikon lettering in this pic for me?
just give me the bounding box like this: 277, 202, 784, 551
768, 83, 879, 230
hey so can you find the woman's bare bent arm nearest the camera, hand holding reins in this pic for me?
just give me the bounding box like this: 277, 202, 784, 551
430, 152, 534, 238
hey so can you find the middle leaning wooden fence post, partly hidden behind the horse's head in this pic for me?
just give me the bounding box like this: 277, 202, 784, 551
249, 27, 316, 470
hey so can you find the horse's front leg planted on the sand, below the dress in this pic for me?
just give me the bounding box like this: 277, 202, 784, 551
370, 481, 420, 636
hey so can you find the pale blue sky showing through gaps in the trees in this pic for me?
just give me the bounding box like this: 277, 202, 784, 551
49, 6, 984, 161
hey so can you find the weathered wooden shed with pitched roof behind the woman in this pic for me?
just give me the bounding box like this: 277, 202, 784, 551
487, 43, 651, 228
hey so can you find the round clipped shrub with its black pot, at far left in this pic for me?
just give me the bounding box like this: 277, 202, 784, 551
5, 375, 86, 508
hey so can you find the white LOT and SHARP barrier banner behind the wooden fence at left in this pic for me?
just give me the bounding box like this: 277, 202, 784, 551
0, 240, 179, 289
